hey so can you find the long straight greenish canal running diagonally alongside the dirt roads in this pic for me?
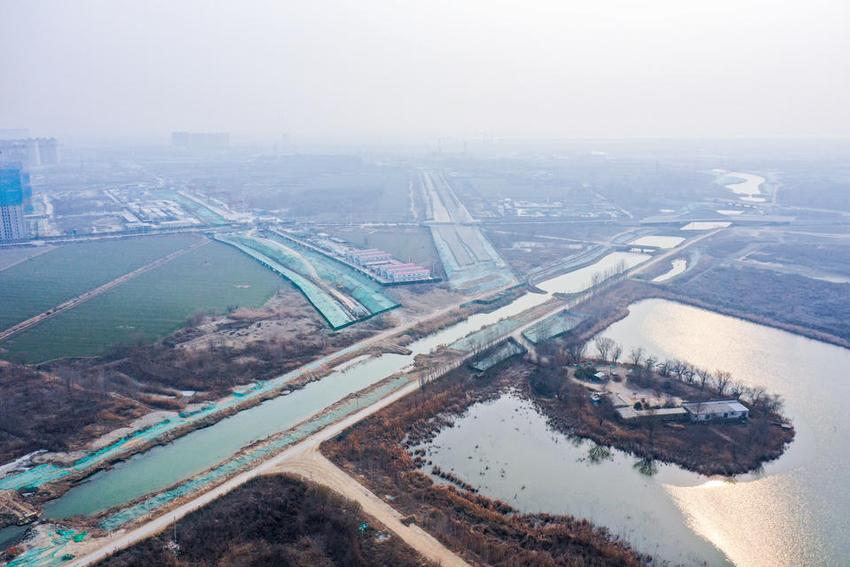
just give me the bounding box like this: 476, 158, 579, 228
34, 252, 649, 519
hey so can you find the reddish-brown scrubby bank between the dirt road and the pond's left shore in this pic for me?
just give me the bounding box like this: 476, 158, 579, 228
322, 368, 648, 566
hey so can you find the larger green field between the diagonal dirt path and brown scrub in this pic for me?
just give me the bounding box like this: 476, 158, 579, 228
0, 242, 283, 363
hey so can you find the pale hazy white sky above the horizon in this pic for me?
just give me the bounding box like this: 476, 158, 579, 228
0, 0, 850, 143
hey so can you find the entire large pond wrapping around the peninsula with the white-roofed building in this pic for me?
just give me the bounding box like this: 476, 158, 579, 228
416, 300, 850, 567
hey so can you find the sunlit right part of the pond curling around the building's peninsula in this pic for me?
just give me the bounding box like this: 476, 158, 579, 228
605, 300, 850, 567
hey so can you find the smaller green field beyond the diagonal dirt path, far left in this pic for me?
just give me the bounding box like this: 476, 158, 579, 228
0, 235, 199, 329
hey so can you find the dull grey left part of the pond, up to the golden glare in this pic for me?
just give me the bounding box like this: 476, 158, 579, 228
418, 393, 728, 565
